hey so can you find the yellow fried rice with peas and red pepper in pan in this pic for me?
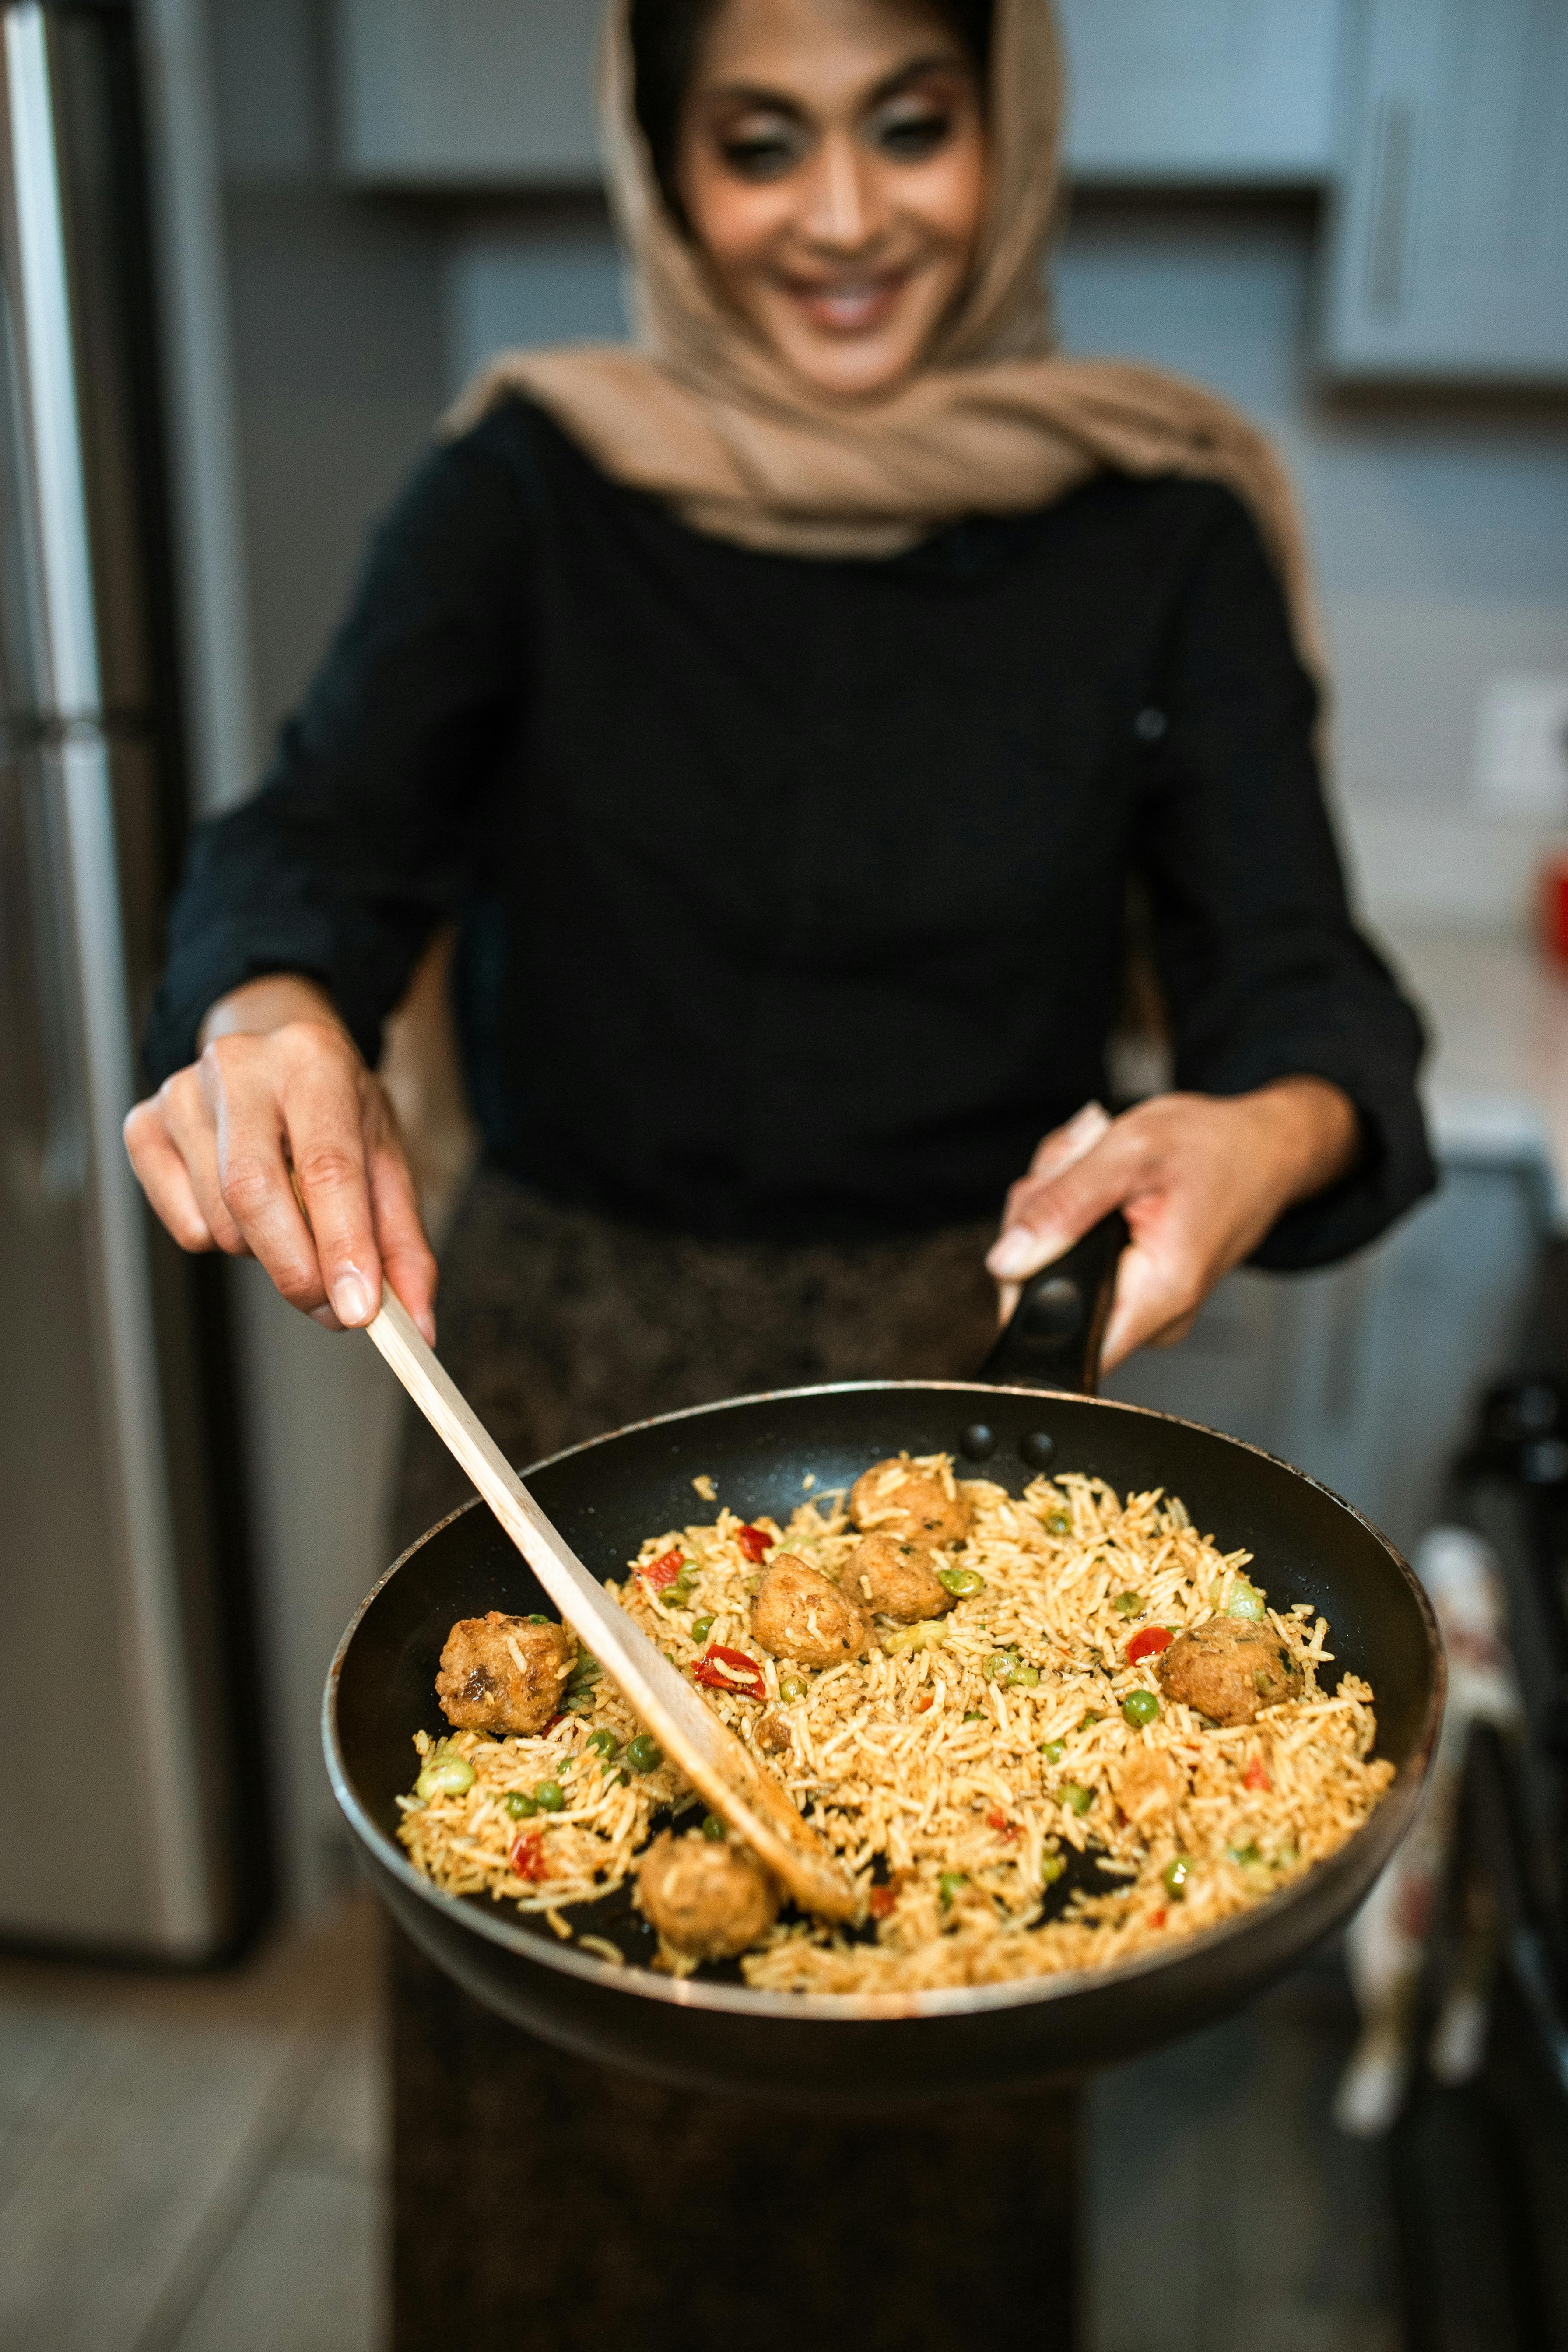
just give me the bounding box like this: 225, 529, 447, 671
397, 1456, 1394, 1994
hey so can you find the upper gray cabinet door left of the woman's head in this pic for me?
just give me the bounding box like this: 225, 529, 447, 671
334, 0, 602, 188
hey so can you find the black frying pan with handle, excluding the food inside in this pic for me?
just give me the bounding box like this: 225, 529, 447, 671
322, 1218, 1446, 2112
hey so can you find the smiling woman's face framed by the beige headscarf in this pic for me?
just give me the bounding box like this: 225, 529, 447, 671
667, 0, 987, 397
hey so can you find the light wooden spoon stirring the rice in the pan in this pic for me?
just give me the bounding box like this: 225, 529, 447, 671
367, 1284, 860, 1919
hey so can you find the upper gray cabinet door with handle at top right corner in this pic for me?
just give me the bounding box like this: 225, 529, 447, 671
1323, 0, 1568, 383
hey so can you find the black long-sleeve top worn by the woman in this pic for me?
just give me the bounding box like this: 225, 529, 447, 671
148, 400, 1431, 1265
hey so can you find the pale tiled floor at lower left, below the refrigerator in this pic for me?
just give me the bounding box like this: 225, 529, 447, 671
0, 1905, 386, 2352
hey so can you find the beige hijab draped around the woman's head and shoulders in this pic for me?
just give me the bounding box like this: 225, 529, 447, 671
447, 0, 1319, 656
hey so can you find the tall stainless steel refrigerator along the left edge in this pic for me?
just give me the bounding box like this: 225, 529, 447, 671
0, 5, 259, 1962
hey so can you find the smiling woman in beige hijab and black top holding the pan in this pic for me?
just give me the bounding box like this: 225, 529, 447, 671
127, 0, 1431, 1534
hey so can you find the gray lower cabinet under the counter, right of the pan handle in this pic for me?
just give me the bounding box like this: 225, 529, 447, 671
1105, 1159, 1547, 1583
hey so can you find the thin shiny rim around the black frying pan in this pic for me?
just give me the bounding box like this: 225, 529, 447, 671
322, 1381, 1448, 2025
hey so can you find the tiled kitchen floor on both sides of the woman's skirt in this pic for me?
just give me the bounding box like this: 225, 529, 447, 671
0, 1903, 1399, 2352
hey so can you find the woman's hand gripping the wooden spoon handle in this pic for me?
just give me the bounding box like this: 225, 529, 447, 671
125, 974, 435, 1341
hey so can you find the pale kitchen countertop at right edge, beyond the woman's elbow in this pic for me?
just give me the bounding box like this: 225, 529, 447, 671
1385, 929, 1568, 1232
